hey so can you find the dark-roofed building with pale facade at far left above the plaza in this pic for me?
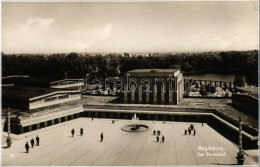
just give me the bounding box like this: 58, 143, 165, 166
2, 86, 81, 110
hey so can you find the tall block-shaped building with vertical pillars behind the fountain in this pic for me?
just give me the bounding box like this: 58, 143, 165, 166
120, 69, 184, 105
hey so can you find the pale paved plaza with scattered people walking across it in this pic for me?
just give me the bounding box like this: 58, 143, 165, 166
2, 118, 257, 166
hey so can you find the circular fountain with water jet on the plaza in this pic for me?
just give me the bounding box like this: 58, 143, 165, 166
121, 114, 149, 132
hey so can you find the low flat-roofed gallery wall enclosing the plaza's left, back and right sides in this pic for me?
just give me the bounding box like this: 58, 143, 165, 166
5, 106, 258, 149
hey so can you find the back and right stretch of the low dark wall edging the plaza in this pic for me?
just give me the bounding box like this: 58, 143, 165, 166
84, 109, 258, 149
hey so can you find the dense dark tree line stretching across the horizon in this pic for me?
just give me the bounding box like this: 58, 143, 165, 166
2, 50, 258, 85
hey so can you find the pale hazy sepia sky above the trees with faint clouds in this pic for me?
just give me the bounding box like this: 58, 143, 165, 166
2, 1, 259, 54
